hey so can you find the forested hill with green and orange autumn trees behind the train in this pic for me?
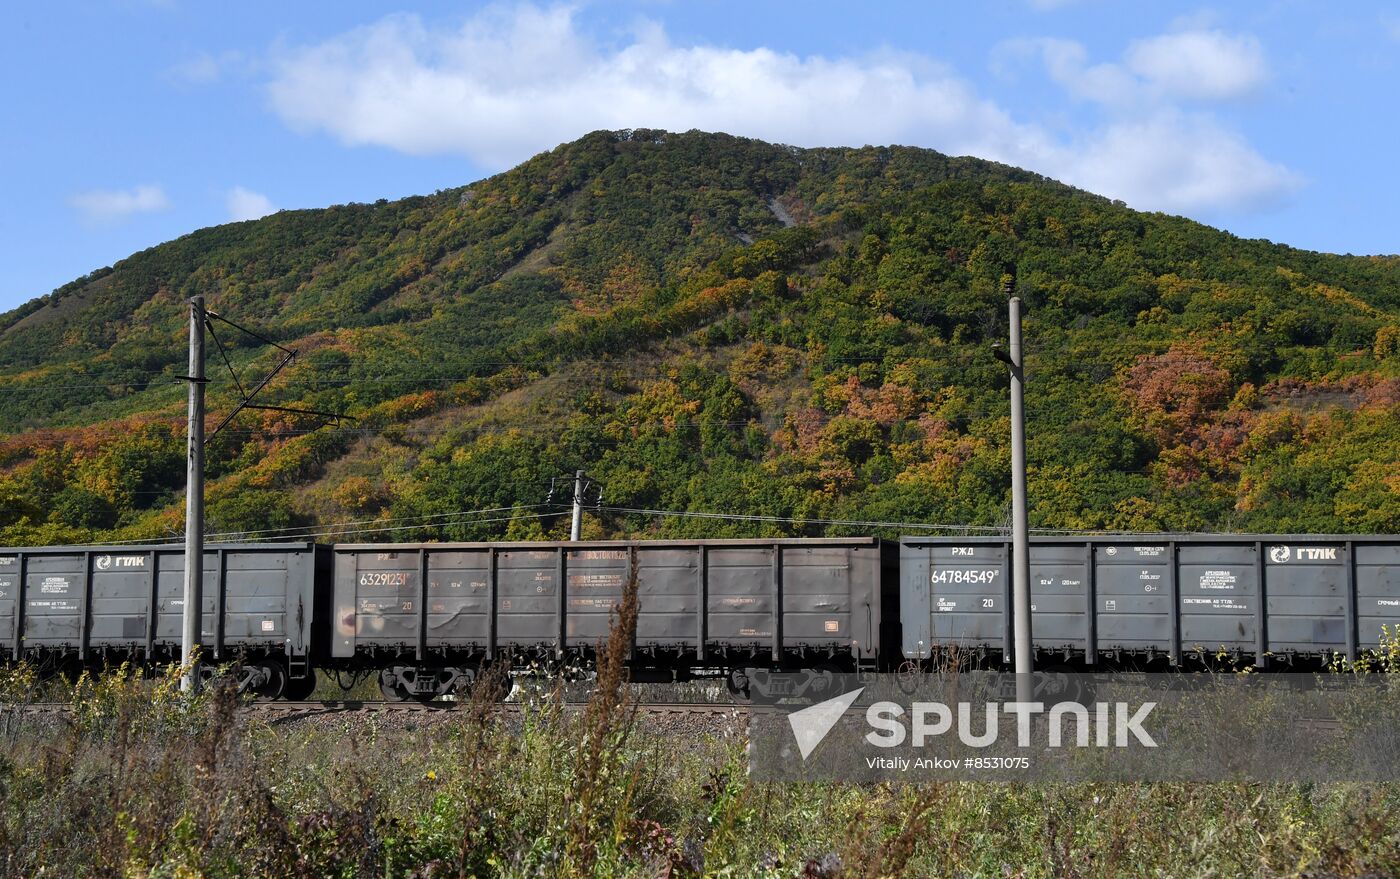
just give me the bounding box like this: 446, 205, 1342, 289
0, 130, 1400, 544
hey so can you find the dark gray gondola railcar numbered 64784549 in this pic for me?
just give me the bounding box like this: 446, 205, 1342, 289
900, 535, 1400, 665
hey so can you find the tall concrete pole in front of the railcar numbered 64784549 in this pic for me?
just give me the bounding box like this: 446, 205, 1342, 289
1008, 297, 1033, 701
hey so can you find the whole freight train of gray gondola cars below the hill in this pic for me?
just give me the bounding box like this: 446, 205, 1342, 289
0, 535, 1400, 700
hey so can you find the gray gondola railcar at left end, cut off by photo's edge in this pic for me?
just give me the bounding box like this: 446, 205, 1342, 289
0, 543, 328, 696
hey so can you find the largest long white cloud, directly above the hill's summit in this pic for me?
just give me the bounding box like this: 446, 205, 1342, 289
270, 6, 1033, 167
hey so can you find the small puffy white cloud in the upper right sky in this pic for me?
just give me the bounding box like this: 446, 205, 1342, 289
1124, 31, 1268, 101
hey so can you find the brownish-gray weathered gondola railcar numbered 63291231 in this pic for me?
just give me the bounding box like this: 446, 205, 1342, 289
330, 537, 897, 697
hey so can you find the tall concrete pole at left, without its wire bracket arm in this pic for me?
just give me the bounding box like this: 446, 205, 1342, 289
181, 294, 204, 693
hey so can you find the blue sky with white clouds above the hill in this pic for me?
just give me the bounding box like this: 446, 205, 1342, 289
0, 0, 1400, 312
